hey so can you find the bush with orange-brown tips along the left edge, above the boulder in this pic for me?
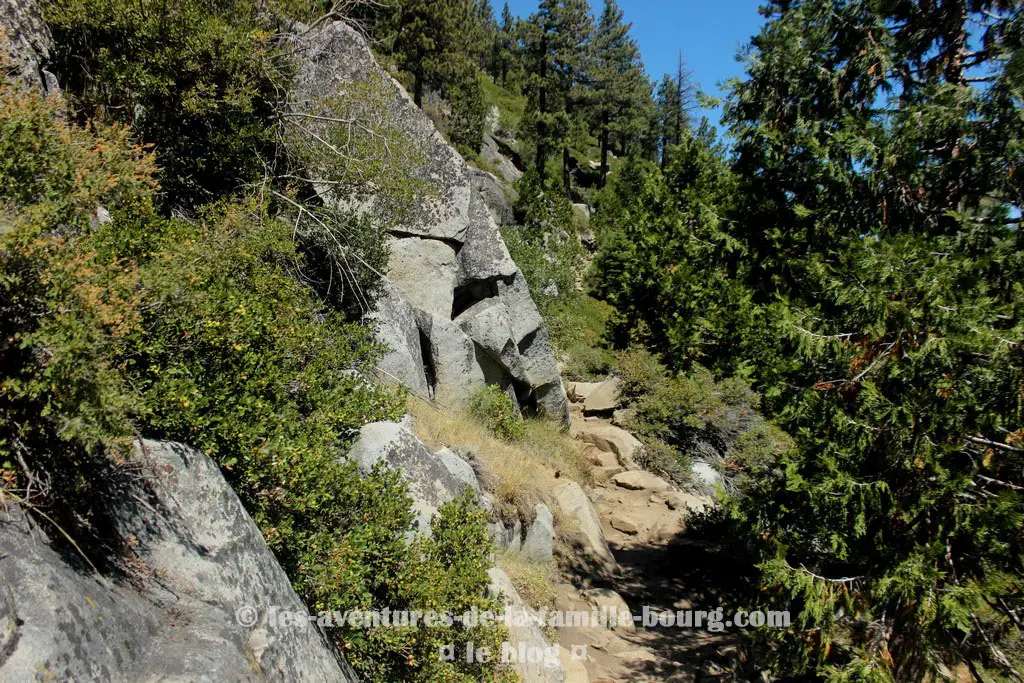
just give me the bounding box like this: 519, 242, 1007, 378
0, 68, 156, 532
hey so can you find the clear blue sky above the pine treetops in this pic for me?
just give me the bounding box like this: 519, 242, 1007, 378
503, 0, 764, 123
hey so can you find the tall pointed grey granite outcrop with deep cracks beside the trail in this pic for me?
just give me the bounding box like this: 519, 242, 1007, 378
290, 23, 569, 425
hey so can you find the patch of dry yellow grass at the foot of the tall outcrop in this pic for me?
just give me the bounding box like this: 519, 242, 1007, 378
409, 397, 591, 521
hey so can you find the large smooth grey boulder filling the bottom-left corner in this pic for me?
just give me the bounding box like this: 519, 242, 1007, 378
0, 441, 358, 681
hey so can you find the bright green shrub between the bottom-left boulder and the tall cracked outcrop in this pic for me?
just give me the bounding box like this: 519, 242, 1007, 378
127, 205, 505, 681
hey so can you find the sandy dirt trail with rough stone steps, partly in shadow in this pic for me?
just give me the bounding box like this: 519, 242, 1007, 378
556, 382, 744, 683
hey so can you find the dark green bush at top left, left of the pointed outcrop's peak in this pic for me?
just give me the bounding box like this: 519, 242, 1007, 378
44, 0, 286, 208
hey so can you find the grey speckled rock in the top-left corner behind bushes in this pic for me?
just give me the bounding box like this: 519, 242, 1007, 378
0, 0, 57, 93
